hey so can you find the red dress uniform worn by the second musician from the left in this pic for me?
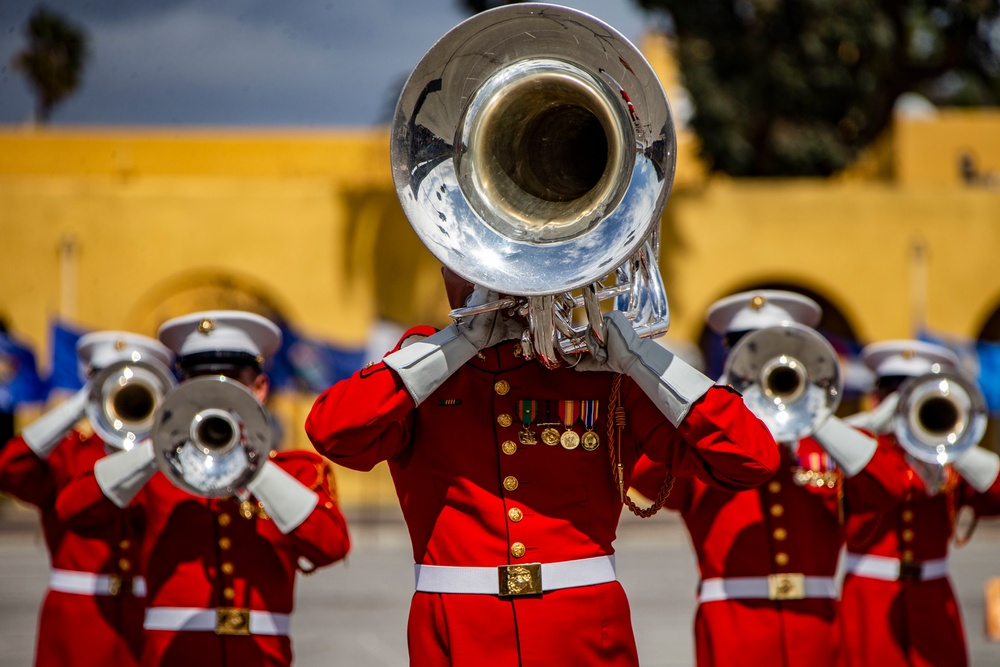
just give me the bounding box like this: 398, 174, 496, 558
58, 451, 350, 667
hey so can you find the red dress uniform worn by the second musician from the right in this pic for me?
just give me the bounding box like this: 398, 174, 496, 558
632, 438, 906, 667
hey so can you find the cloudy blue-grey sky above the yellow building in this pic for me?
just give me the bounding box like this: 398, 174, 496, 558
0, 0, 652, 127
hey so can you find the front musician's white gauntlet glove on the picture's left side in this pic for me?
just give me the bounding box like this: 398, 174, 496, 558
383, 287, 524, 405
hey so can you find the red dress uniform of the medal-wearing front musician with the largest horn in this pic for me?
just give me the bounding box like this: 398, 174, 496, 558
306, 328, 777, 667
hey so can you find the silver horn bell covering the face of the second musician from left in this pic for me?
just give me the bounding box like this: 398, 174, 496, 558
152, 375, 271, 498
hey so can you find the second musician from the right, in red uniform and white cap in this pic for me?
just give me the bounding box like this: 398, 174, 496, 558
633, 290, 905, 667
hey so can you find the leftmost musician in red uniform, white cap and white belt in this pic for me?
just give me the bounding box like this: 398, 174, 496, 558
0, 331, 173, 667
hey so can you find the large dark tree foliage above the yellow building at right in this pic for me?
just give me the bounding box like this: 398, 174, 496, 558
637, 0, 1000, 176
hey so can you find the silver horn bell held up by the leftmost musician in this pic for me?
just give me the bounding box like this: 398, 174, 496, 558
86, 359, 176, 450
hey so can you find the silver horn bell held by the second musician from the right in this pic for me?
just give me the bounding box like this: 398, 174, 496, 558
725, 323, 843, 442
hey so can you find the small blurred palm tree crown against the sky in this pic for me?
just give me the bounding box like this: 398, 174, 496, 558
12, 7, 87, 123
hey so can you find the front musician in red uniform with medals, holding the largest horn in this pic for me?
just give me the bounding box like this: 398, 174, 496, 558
306, 269, 777, 667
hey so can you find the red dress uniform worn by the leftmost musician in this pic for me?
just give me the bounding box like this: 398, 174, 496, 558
0, 431, 145, 667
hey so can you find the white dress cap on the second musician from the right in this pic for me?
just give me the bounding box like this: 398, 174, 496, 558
705, 290, 823, 336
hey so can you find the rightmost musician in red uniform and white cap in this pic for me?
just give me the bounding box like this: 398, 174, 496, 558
841, 340, 1000, 667
